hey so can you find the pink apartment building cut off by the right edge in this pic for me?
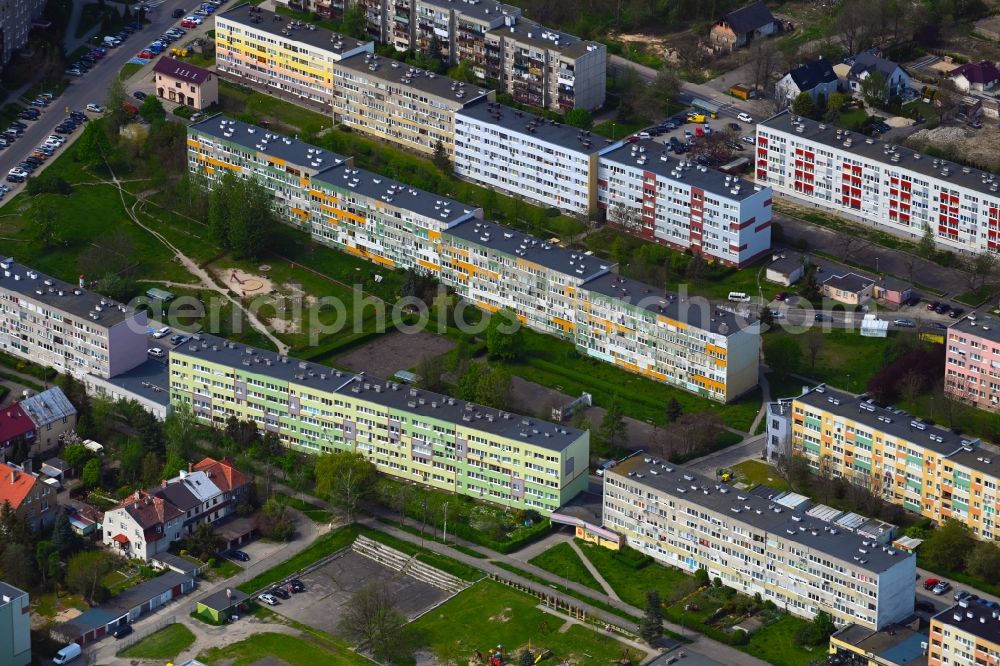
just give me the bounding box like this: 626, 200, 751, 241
944, 314, 1000, 412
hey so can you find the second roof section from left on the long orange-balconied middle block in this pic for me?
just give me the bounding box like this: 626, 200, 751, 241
313, 166, 480, 226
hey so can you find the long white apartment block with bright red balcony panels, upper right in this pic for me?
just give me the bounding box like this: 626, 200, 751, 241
756, 111, 1000, 253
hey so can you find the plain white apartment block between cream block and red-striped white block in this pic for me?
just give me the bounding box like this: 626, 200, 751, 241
455, 98, 619, 215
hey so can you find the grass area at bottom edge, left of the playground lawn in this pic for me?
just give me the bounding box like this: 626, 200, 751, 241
198, 633, 371, 666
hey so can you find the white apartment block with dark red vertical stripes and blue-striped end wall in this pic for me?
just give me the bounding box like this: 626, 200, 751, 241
597, 140, 771, 267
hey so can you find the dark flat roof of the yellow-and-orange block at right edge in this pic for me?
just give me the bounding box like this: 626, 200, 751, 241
796, 386, 980, 457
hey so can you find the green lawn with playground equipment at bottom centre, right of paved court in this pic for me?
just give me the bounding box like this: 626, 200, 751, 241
411, 581, 641, 664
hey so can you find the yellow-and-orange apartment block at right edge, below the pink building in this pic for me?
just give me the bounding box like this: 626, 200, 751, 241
784, 386, 1000, 540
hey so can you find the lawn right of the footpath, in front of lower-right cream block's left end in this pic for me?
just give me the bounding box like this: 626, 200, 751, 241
577, 540, 696, 608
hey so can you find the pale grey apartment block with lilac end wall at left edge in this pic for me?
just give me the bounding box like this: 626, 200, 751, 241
0, 257, 147, 378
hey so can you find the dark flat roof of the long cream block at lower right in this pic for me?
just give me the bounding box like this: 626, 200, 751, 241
605, 454, 914, 574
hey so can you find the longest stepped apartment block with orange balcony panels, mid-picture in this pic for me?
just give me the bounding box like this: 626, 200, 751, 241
188, 116, 760, 402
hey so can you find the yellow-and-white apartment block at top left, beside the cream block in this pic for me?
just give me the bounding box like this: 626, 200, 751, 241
215, 4, 375, 111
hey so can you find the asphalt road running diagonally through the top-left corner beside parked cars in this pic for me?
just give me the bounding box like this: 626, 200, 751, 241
0, 0, 198, 189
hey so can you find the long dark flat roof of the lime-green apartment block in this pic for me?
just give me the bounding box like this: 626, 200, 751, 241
170, 334, 583, 451
